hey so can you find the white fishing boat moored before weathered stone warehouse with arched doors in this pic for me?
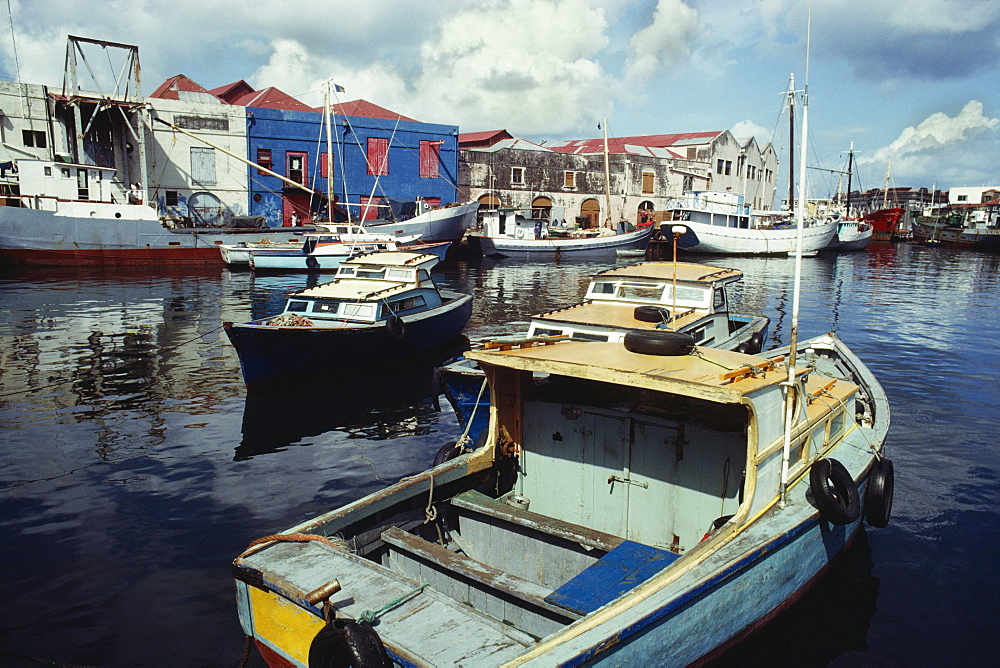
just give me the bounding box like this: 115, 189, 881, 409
468, 209, 654, 257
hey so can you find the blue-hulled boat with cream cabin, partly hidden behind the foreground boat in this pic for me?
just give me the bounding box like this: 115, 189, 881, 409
441, 262, 769, 448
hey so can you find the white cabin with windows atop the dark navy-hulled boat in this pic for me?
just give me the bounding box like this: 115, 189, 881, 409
278, 252, 443, 327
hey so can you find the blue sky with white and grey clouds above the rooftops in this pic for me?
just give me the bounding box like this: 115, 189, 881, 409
0, 0, 1000, 197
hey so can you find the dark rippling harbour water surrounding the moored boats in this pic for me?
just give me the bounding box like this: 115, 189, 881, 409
0, 243, 1000, 666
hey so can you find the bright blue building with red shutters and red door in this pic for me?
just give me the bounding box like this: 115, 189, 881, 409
247, 95, 458, 226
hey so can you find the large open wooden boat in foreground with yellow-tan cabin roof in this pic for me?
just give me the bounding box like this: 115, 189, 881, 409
233, 332, 893, 666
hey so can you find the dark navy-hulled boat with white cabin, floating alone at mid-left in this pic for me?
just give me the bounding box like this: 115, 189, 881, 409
223, 252, 472, 385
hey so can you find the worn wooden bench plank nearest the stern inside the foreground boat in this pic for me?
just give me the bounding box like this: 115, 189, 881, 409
382, 527, 579, 621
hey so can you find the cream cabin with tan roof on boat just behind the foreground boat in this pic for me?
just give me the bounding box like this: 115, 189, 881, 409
528, 262, 766, 352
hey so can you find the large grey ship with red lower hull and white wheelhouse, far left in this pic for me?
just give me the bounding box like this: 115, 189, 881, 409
0, 160, 315, 266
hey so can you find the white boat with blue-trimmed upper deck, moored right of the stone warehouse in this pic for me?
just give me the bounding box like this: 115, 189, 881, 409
661, 191, 837, 255
